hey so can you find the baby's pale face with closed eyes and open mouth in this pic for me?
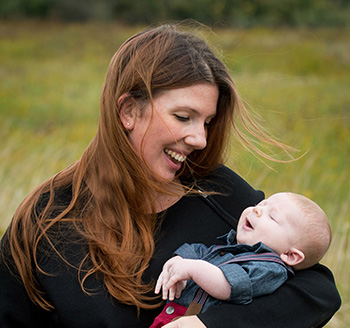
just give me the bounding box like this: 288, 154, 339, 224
237, 193, 303, 254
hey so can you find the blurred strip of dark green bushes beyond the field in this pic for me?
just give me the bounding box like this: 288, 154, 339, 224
0, 0, 350, 27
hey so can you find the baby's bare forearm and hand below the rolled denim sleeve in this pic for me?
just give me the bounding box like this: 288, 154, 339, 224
155, 256, 231, 301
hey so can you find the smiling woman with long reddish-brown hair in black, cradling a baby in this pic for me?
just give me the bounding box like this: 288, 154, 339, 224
0, 26, 340, 328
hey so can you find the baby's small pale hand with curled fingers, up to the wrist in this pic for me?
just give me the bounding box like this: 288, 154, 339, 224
155, 256, 191, 301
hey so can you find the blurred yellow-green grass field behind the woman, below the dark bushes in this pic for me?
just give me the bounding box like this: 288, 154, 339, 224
0, 22, 350, 328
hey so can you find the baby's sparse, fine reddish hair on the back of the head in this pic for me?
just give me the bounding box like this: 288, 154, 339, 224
288, 193, 332, 270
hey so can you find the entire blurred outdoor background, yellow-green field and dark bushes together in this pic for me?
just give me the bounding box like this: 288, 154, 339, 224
0, 0, 350, 328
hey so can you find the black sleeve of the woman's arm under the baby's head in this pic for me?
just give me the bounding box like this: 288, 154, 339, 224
198, 264, 341, 328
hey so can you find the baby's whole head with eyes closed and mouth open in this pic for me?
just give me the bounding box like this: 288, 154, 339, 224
237, 192, 331, 270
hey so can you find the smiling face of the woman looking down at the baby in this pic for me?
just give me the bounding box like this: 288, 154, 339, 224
124, 83, 219, 181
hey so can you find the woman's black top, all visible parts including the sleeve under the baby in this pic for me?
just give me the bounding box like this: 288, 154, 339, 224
0, 167, 340, 328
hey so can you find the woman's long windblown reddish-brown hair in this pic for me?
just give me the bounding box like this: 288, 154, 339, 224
3, 25, 292, 310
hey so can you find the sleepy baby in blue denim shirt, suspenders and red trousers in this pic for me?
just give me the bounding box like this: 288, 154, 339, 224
151, 192, 331, 328
